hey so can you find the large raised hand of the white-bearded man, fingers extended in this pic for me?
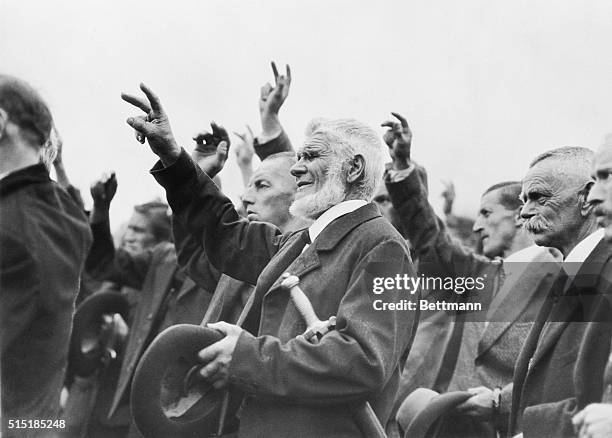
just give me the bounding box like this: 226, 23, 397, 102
121, 83, 181, 167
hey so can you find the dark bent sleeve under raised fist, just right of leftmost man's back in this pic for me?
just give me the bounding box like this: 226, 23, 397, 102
85, 221, 153, 289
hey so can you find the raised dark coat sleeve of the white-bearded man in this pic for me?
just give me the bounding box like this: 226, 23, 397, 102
151, 150, 282, 284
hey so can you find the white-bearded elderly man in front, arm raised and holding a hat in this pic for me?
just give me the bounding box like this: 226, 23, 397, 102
123, 85, 419, 438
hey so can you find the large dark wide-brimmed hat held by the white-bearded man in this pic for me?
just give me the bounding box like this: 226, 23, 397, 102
130, 324, 241, 438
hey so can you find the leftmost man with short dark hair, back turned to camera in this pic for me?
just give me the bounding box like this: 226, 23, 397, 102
0, 75, 91, 437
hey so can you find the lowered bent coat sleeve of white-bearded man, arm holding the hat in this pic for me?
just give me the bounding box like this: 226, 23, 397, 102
229, 240, 418, 404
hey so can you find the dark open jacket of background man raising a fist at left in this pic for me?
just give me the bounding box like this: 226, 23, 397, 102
87, 223, 218, 416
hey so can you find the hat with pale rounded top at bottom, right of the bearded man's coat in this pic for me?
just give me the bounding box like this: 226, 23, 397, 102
395, 388, 474, 438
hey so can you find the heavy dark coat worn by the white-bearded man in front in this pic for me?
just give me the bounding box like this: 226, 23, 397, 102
152, 152, 418, 437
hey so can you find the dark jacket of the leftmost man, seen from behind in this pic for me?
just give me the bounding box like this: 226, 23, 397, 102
0, 164, 91, 437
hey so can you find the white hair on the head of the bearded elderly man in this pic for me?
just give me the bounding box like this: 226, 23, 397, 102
306, 118, 387, 201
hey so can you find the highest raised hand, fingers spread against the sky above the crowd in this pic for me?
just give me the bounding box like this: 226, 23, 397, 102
259, 62, 291, 141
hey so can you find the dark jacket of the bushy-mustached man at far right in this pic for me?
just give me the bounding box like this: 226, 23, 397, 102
510, 241, 612, 438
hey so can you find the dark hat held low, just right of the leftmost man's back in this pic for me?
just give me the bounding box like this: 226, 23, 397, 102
68, 291, 130, 377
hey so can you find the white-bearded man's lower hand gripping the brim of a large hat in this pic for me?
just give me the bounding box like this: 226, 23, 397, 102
198, 322, 242, 389
